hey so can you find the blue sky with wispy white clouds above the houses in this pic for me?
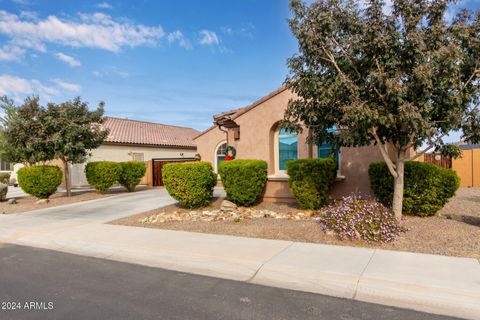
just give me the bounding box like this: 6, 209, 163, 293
0, 0, 480, 138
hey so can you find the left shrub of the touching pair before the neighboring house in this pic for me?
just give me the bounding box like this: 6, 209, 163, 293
85, 161, 120, 193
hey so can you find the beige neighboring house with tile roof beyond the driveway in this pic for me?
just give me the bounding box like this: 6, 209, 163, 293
66, 117, 199, 187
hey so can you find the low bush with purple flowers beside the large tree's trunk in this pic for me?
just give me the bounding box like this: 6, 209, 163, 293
317, 195, 402, 242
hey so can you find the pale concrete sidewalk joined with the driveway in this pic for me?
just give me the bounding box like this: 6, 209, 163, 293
0, 189, 480, 319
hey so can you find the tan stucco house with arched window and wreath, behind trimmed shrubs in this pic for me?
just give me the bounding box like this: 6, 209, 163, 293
194, 87, 390, 201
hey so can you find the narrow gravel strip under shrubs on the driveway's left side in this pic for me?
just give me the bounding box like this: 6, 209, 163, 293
0, 186, 149, 214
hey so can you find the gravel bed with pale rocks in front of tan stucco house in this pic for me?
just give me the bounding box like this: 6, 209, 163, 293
112, 188, 480, 258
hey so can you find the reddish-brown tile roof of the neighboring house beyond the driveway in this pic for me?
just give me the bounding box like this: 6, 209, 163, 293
103, 117, 199, 148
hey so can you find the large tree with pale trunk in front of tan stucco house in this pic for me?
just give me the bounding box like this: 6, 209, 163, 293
284, 0, 480, 219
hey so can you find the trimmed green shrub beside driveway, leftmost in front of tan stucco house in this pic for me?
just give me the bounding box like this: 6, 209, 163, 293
162, 162, 217, 208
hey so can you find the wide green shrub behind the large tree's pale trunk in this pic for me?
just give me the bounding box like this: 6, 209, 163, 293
368, 161, 460, 216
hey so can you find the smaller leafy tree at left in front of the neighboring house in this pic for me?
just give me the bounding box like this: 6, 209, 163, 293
0, 97, 108, 196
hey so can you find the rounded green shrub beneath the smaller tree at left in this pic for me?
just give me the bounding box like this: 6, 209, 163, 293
17, 166, 63, 199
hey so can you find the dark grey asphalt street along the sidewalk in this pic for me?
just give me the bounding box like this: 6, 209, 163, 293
0, 244, 462, 320
